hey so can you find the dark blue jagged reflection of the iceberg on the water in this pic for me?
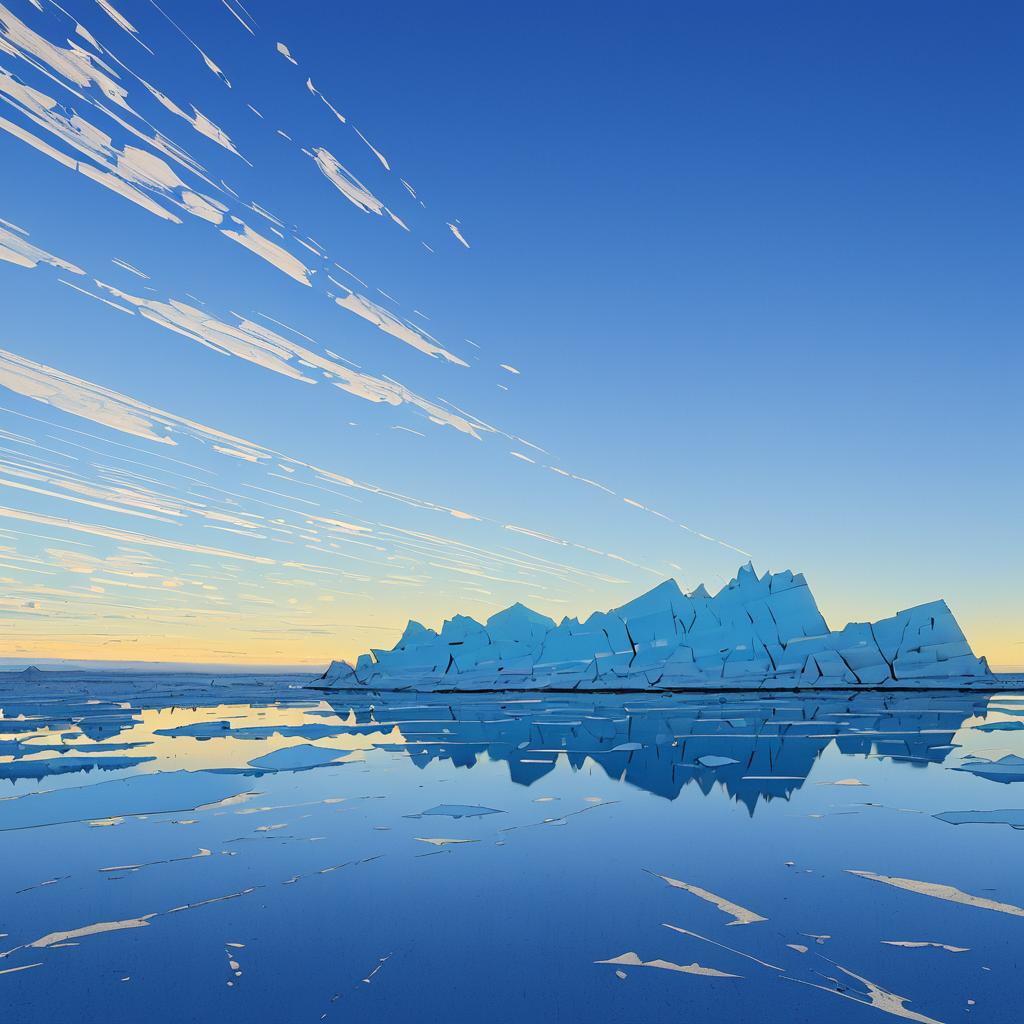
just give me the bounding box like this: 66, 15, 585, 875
325, 695, 986, 814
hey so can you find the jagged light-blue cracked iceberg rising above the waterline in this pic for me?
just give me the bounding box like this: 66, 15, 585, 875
322, 562, 993, 691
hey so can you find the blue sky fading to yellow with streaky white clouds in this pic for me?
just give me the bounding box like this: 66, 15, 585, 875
0, 0, 1024, 668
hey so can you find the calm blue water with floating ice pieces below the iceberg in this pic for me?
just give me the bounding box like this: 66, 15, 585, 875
0, 683, 1024, 1024
